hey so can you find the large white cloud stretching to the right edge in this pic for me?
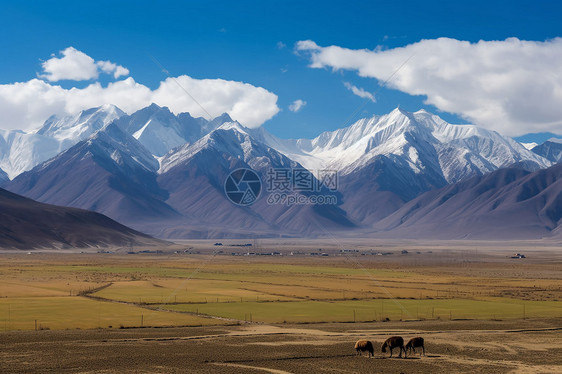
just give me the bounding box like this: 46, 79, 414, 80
295, 38, 562, 136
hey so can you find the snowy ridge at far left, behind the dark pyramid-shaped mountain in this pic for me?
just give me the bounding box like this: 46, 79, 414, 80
0, 104, 232, 179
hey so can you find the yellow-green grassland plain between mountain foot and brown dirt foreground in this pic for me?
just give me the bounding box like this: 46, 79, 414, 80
0, 248, 562, 331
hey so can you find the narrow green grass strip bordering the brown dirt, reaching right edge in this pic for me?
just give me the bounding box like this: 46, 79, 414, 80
159, 299, 562, 323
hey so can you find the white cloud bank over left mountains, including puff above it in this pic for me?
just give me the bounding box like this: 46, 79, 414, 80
0, 47, 279, 130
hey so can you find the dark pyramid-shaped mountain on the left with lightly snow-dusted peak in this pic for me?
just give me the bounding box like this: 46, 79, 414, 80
5, 123, 179, 224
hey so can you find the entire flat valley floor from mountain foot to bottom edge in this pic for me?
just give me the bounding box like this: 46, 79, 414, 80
0, 240, 562, 374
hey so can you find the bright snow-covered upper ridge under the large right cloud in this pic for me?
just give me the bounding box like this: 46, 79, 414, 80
261, 108, 551, 183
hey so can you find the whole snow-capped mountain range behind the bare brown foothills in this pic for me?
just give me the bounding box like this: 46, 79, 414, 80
0, 104, 562, 238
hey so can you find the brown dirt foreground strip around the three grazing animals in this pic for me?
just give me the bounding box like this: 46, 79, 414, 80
0, 319, 562, 374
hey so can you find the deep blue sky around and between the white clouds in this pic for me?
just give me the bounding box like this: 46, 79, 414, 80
0, 1, 562, 137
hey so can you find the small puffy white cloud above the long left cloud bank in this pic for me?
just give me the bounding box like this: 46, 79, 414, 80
39, 47, 129, 82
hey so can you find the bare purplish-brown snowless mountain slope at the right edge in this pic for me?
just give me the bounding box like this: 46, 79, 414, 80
374, 164, 562, 240
